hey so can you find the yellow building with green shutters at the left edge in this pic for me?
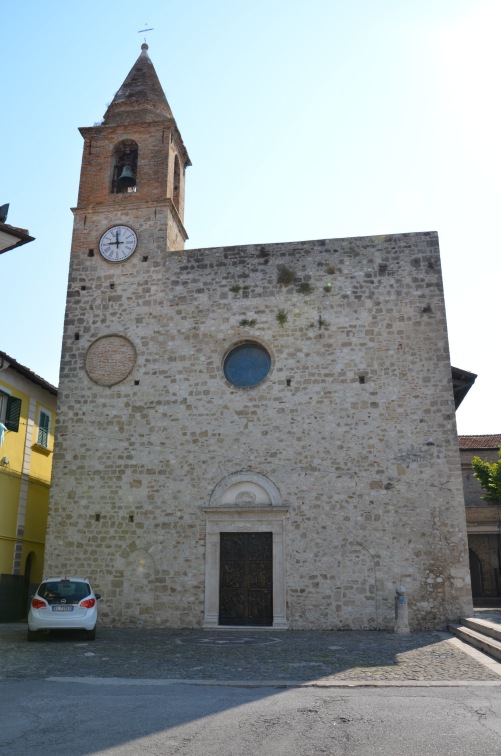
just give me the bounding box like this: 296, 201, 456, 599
0, 351, 57, 622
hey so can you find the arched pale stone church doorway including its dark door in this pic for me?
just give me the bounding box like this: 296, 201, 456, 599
204, 470, 288, 628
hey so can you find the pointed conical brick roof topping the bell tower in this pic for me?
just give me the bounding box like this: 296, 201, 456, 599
104, 43, 173, 126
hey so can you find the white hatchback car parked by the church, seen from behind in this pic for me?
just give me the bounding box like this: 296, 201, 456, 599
28, 577, 101, 641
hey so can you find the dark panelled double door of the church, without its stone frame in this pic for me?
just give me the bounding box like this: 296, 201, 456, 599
219, 533, 273, 626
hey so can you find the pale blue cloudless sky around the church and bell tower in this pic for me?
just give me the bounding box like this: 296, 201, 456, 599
0, 0, 501, 434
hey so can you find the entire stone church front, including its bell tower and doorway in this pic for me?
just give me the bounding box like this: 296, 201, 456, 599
45, 45, 471, 629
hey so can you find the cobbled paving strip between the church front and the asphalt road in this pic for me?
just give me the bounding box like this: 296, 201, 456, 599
0, 623, 501, 684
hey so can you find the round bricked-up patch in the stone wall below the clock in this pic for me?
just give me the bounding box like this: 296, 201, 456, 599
85, 336, 136, 386
